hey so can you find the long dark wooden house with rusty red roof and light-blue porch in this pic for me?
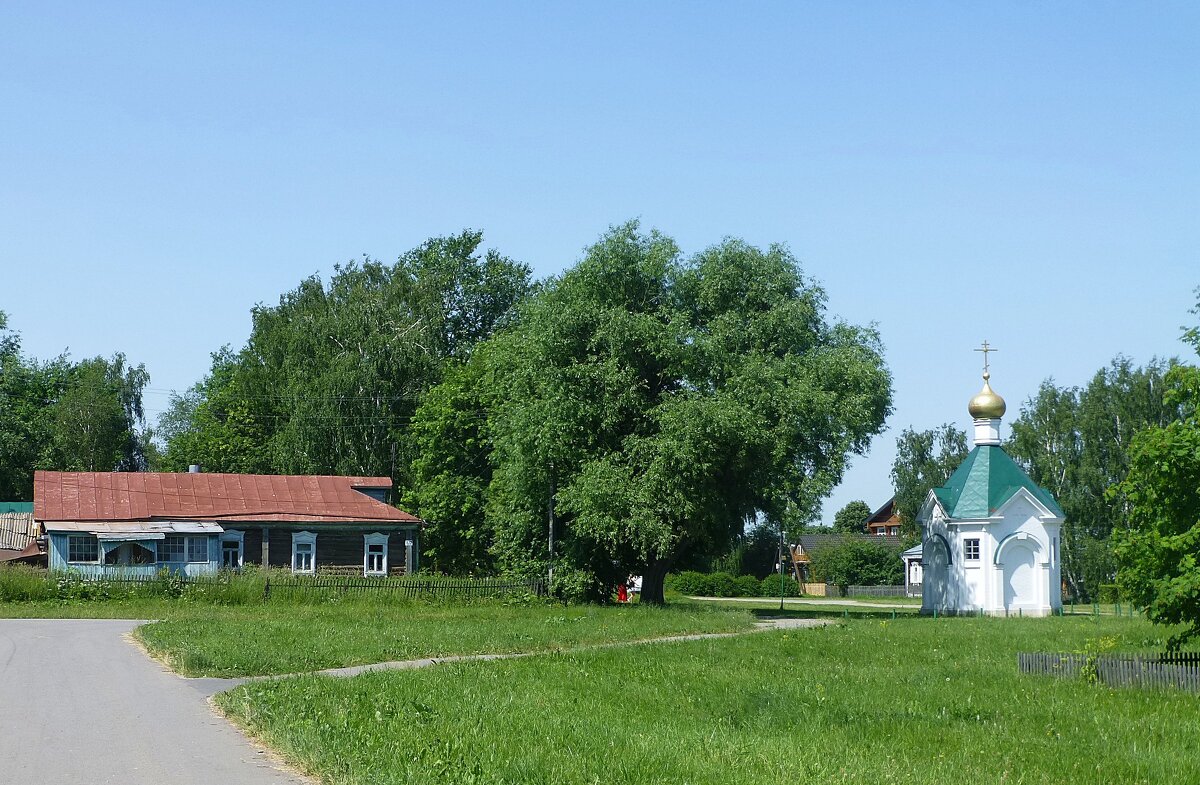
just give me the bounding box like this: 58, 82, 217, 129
34, 472, 421, 576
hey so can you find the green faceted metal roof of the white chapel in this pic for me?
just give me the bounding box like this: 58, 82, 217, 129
934, 444, 1066, 519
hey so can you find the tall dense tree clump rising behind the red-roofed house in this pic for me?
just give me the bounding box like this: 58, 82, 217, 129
162, 230, 529, 487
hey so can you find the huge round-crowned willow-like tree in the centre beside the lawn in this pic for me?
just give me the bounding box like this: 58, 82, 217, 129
432, 223, 890, 603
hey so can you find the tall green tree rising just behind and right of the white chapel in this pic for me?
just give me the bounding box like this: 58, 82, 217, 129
1004, 356, 1178, 601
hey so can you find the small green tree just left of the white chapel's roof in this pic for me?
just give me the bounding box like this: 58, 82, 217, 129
892, 423, 967, 538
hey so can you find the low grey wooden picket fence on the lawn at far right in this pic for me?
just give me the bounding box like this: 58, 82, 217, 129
1016, 652, 1200, 693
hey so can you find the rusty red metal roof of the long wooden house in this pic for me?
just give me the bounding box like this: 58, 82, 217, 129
34, 472, 419, 523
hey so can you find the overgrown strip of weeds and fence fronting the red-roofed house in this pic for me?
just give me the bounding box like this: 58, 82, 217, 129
0, 565, 546, 605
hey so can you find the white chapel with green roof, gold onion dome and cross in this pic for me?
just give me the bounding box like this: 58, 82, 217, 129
917, 341, 1064, 616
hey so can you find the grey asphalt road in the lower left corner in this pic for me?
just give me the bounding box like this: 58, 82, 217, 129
0, 619, 305, 785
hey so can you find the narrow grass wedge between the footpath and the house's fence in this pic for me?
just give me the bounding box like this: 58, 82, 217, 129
129, 603, 754, 677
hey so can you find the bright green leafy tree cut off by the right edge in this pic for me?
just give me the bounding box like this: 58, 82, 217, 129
1110, 289, 1200, 648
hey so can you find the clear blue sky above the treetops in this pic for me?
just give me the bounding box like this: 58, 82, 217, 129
0, 0, 1200, 520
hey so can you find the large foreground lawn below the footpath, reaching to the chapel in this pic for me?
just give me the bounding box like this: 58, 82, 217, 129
217, 617, 1200, 785
